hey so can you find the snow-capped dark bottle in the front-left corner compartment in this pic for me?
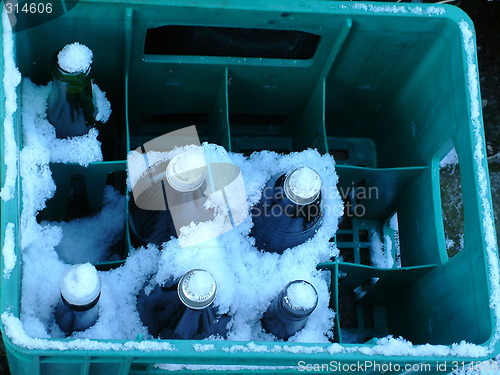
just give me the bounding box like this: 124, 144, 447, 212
55, 263, 101, 336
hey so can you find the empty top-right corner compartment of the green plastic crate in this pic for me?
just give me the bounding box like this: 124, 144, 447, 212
325, 15, 468, 167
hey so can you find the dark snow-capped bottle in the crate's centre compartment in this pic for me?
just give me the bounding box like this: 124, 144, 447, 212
129, 151, 214, 246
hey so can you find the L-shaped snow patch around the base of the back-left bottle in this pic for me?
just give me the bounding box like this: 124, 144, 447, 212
22, 78, 102, 166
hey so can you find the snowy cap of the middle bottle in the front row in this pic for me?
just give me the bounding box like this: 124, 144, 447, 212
177, 269, 217, 310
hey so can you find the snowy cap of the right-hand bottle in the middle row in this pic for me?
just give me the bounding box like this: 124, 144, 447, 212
284, 167, 321, 205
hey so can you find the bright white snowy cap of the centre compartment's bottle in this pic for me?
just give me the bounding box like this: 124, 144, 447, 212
166, 151, 207, 192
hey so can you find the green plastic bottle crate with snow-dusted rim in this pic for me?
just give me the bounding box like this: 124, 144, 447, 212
0, 0, 500, 375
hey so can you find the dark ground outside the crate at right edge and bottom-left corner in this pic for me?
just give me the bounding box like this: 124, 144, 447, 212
0, 0, 500, 375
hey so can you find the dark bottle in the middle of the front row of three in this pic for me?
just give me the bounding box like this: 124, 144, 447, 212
137, 269, 230, 340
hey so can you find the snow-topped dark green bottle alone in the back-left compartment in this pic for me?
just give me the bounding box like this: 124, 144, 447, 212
47, 43, 97, 138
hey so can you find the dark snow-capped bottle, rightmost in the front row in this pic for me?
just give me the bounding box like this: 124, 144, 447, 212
261, 280, 318, 340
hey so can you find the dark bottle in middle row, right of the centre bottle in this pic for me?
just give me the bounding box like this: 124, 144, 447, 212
251, 167, 323, 254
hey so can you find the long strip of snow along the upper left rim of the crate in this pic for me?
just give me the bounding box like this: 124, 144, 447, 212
0, 8, 21, 201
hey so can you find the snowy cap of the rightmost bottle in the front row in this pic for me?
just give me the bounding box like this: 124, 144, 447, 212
283, 280, 318, 315
